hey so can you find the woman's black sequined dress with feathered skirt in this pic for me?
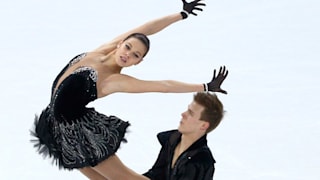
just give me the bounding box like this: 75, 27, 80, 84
31, 53, 129, 169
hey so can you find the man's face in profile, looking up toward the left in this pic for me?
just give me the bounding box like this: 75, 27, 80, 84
178, 101, 208, 134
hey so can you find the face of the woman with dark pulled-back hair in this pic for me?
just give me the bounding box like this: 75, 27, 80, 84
116, 37, 146, 67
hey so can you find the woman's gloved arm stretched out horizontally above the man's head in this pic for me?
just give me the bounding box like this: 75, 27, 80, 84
99, 66, 228, 97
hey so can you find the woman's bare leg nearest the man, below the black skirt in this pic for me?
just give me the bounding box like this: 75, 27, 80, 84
92, 155, 148, 180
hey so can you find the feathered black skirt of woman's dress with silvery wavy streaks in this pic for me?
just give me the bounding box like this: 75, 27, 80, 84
31, 106, 129, 170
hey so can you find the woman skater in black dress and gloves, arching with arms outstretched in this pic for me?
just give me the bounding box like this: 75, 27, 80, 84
32, 0, 228, 180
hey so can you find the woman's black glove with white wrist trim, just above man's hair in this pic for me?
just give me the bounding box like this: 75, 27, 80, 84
203, 66, 228, 94
